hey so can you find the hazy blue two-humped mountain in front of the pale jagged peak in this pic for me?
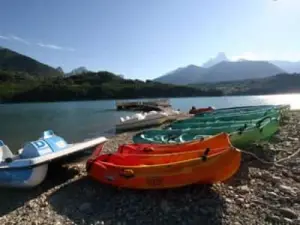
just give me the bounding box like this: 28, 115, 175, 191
154, 59, 285, 85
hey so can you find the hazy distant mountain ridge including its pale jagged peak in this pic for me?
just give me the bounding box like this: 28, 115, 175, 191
154, 52, 292, 85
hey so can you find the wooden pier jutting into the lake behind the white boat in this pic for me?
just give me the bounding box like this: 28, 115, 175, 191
116, 99, 171, 112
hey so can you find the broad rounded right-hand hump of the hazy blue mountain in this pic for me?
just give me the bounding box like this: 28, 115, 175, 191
194, 60, 285, 83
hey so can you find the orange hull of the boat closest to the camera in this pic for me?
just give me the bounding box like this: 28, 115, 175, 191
87, 148, 241, 189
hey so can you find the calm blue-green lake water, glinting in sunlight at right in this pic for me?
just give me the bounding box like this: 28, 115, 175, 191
0, 94, 300, 151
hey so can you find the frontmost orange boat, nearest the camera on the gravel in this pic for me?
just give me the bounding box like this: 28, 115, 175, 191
86, 136, 241, 189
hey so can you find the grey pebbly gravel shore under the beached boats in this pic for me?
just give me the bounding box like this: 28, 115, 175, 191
0, 111, 300, 225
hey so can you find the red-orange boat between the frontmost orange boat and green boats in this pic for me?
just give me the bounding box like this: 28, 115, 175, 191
115, 133, 231, 156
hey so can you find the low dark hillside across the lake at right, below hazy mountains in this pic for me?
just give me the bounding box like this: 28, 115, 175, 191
190, 74, 300, 95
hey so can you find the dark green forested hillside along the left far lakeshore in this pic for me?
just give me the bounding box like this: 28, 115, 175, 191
0, 71, 222, 102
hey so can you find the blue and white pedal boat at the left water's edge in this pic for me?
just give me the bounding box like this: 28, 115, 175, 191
0, 130, 106, 188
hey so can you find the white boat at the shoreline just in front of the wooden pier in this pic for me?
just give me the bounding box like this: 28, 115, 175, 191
116, 110, 180, 131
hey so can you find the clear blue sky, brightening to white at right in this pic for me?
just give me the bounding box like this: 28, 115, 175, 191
0, 0, 300, 80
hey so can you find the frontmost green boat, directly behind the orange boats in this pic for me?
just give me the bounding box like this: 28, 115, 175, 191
133, 117, 279, 147
